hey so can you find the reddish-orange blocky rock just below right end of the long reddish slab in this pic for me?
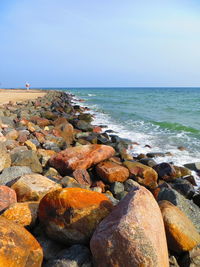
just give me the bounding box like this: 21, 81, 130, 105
96, 161, 129, 183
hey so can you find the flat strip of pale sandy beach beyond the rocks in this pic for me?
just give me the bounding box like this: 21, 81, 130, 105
0, 89, 46, 104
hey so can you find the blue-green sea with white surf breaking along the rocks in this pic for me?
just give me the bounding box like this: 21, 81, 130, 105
46, 87, 200, 182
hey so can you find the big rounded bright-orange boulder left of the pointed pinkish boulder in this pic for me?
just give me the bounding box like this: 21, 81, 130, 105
39, 188, 112, 244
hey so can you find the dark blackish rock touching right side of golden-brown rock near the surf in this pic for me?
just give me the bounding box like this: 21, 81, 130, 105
153, 162, 176, 181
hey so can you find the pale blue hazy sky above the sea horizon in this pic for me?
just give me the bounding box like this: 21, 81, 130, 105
0, 0, 200, 88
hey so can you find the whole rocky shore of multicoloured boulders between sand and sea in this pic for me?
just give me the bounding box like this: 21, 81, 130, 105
0, 91, 200, 267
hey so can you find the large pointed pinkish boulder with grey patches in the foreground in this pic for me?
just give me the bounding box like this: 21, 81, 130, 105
90, 186, 169, 267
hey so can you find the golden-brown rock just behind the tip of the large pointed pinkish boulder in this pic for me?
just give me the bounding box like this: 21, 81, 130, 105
124, 161, 158, 189
